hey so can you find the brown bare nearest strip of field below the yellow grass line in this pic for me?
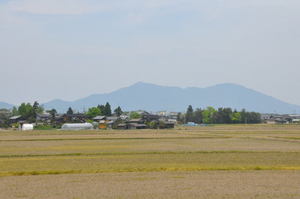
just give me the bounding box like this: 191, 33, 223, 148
0, 171, 300, 199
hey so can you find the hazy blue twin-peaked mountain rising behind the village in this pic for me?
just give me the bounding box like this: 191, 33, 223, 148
44, 82, 300, 113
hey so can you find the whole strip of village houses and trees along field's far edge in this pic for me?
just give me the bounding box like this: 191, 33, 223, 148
0, 102, 300, 130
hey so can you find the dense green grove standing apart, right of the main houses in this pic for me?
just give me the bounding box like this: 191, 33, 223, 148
178, 105, 261, 124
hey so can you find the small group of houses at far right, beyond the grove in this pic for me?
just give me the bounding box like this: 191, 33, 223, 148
261, 114, 300, 124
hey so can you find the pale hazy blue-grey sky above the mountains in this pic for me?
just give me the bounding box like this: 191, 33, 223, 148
0, 0, 300, 105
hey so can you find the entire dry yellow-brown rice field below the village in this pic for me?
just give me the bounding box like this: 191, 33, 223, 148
0, 125, 300, 199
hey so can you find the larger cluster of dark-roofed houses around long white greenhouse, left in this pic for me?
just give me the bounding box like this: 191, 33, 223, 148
9, 111, 177, 130
